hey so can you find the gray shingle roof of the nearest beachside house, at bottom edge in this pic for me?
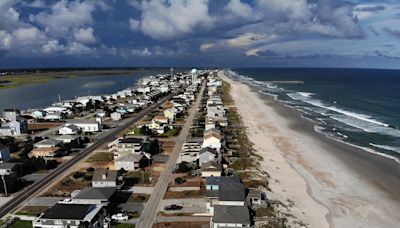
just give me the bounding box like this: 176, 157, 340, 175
213, 205, 251, 225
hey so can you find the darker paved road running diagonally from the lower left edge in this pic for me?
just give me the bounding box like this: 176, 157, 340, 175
0, 91, 178, 218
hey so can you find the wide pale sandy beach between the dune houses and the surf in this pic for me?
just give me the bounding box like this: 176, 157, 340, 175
218, 71, 400, 228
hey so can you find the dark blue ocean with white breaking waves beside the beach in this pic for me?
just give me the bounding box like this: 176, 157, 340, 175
228, 68, 400, 158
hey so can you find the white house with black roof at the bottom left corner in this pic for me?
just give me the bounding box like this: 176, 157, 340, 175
32, 204, 105, 228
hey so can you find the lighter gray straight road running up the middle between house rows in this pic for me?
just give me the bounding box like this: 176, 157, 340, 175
137, 82, 206, 228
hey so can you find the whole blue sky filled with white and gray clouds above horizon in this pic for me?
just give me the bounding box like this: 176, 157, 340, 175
0, 0, 400, 69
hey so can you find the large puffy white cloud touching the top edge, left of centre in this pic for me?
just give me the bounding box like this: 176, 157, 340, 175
130, 0, 213, 40
